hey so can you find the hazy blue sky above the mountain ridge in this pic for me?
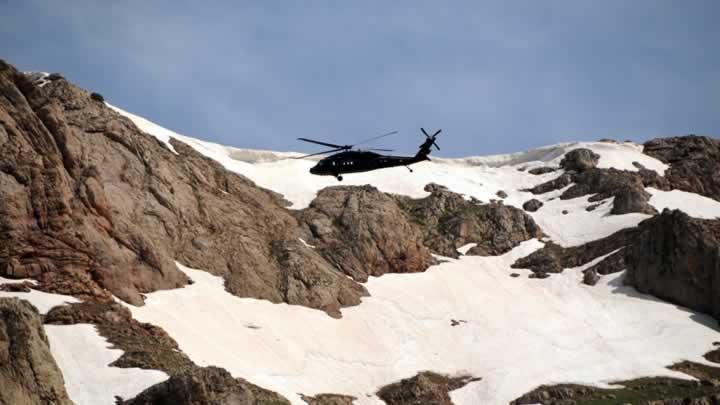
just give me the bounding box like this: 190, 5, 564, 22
0, 0, 720, 157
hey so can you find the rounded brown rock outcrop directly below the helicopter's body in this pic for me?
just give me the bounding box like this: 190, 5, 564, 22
298, 186, 433, 281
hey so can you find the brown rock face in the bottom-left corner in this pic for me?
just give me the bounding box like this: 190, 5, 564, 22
0, 298, 72, 405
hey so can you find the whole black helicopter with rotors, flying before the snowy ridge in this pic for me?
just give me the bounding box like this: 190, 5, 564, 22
295, 128, 442, 181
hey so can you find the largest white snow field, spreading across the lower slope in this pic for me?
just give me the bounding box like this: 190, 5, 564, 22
130, 249, 718, 404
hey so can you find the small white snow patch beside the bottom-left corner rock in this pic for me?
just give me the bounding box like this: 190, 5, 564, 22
45, 324, 168, 405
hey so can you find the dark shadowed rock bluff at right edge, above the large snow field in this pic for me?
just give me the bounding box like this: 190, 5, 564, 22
625, 210, 720, 319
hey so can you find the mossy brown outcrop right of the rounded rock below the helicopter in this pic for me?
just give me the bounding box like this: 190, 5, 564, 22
396, 186, 542, 257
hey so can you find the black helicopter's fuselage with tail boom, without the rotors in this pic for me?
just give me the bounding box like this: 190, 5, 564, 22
310, 150, 430, 179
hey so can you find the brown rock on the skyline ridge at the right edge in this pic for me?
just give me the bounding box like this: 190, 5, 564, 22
643, 135, 720, 201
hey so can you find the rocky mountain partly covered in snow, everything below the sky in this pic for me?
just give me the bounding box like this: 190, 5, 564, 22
0, 58, 720, 405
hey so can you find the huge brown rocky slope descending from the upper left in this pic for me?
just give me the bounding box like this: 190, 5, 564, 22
0, 58, 366, 314
